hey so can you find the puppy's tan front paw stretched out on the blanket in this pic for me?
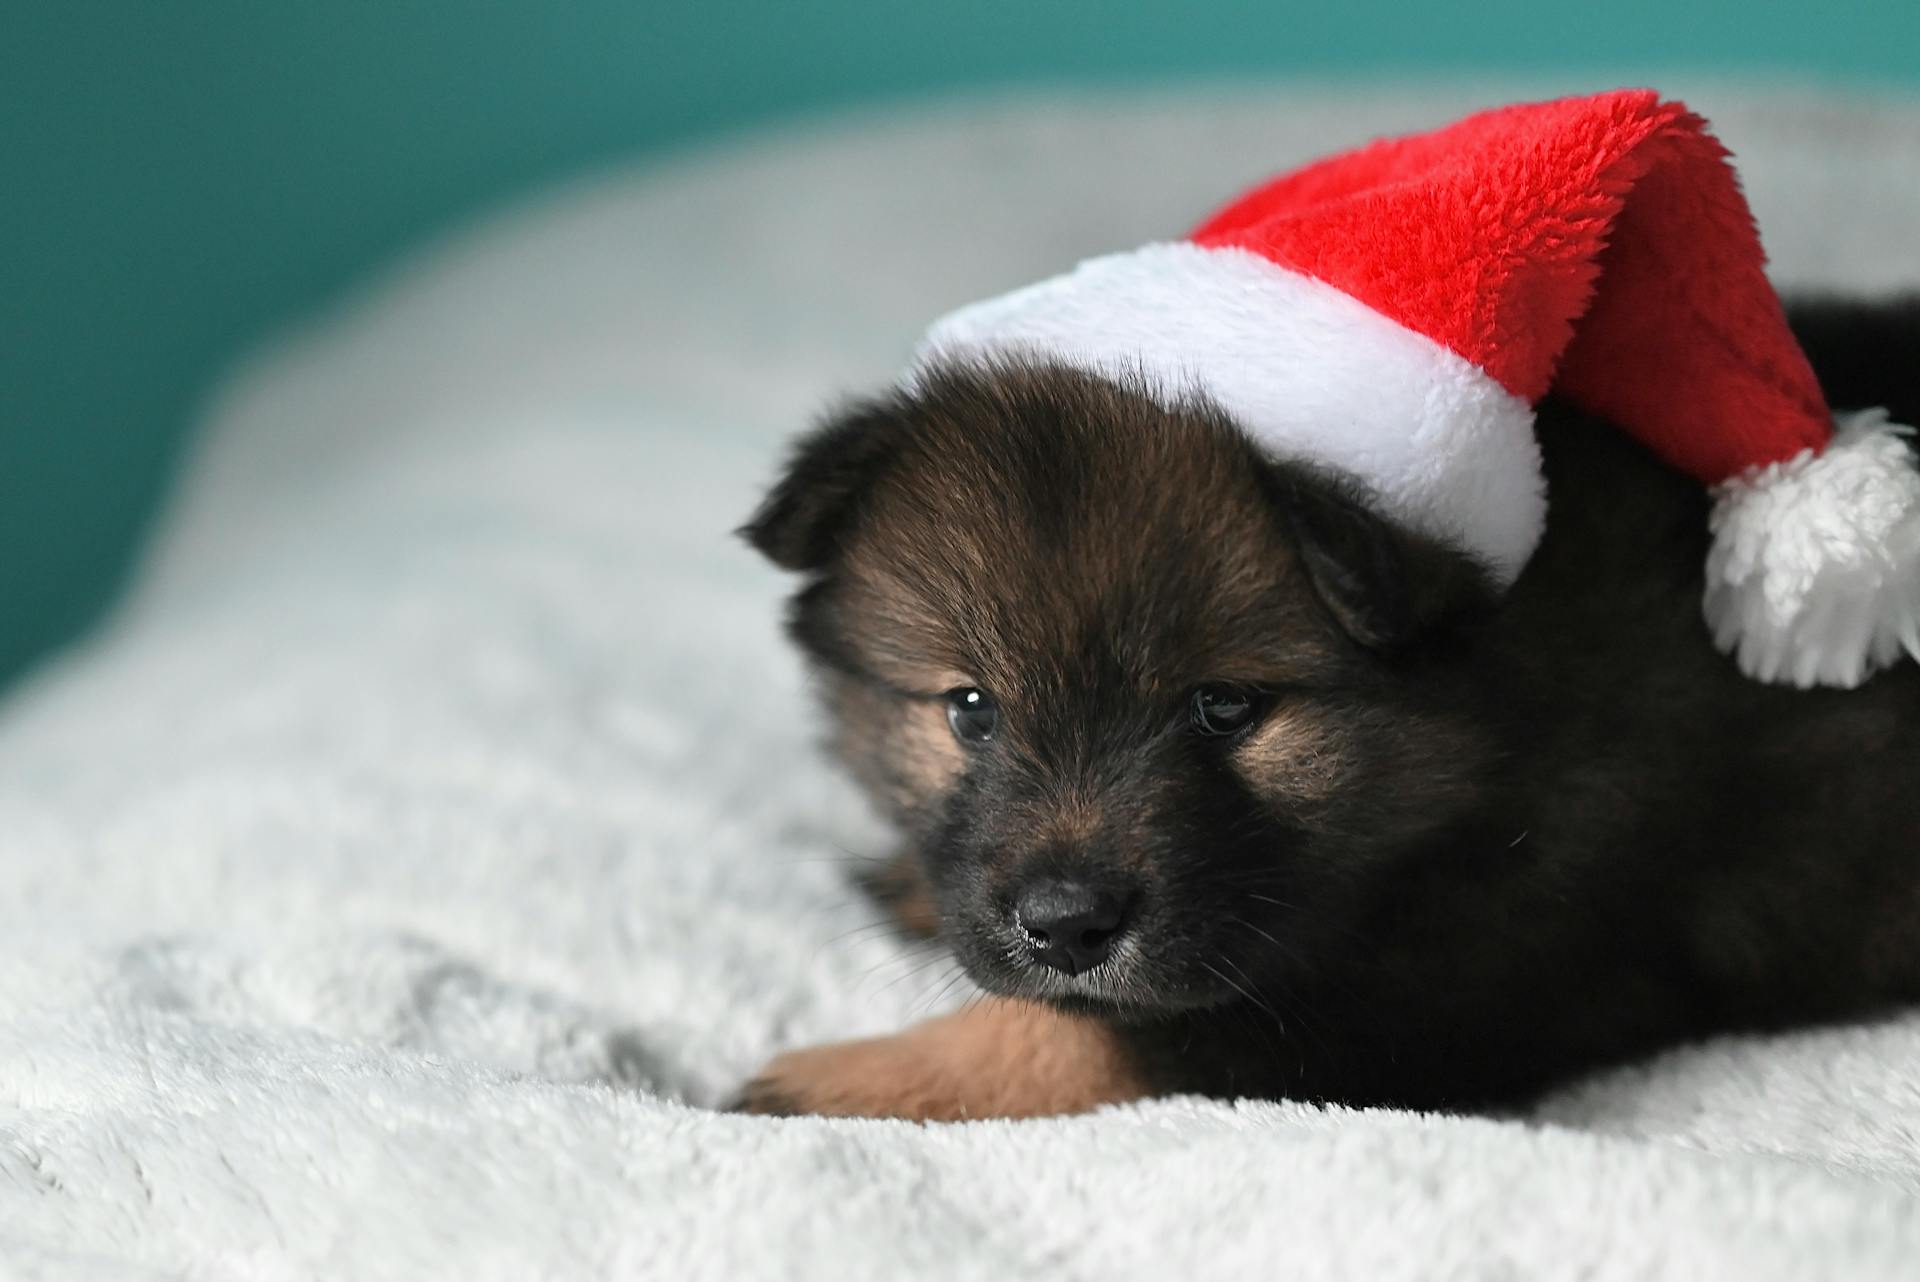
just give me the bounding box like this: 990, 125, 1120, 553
739, 998, 1146, 1121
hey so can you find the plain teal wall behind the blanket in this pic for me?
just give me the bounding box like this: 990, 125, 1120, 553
11, 0, 1920, 683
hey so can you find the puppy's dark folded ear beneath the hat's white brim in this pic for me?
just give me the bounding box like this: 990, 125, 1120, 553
1269, 464, 1500, 653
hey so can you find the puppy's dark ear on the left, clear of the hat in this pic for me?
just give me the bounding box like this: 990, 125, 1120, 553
739, 401, 904, 570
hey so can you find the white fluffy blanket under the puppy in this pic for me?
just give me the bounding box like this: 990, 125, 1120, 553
0, 86, 1920, 1282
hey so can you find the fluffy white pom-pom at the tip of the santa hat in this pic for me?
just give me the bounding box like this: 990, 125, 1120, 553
1705, 409, 1920, 687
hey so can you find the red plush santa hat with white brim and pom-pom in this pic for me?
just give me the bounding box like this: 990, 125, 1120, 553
916, 90, 1920, 685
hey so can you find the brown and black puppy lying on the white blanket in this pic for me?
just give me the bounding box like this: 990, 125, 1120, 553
745, 301, 1920, 1117
